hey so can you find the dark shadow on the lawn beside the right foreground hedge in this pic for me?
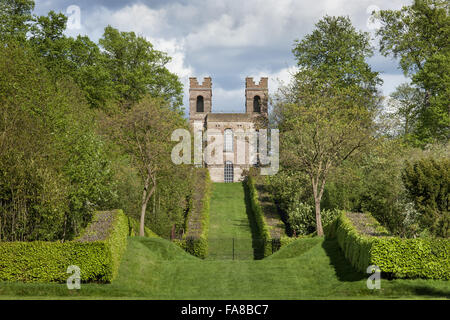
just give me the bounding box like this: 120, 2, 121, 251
322, 240, 367, 282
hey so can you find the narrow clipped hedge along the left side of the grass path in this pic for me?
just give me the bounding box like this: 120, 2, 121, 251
173, 169, 211, 259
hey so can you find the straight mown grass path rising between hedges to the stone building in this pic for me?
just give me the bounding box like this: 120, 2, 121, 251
208, 183, 253, 259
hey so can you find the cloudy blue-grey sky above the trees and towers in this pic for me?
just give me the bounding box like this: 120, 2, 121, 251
34, 0, 411, 112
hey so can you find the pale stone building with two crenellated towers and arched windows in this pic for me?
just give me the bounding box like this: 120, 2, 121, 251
189, 77, 268, 182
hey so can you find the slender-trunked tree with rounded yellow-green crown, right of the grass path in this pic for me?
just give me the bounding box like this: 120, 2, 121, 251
275, 83, 373, 236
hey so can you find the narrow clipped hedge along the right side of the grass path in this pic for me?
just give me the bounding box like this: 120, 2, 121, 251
245, 175, 272, 257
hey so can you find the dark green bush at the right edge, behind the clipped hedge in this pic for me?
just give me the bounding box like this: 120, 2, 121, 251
402, 157, 450, 238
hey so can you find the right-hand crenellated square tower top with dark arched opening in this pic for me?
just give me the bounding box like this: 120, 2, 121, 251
245, 77, 269, 114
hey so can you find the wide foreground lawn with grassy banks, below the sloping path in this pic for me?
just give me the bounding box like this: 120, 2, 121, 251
0, 237, 450, 299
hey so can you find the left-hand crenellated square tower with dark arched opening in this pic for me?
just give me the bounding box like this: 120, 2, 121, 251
189, 77, 212, 125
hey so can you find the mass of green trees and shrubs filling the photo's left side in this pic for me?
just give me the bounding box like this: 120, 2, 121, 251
0, 0, 190, 245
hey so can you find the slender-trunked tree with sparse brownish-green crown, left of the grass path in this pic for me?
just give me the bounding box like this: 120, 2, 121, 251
108, 97, 186, 236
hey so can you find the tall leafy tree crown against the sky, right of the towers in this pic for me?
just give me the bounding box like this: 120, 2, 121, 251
292, 16, 382, 99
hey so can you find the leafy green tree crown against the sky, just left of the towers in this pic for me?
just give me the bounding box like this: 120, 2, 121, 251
99, 26, 183, 109
